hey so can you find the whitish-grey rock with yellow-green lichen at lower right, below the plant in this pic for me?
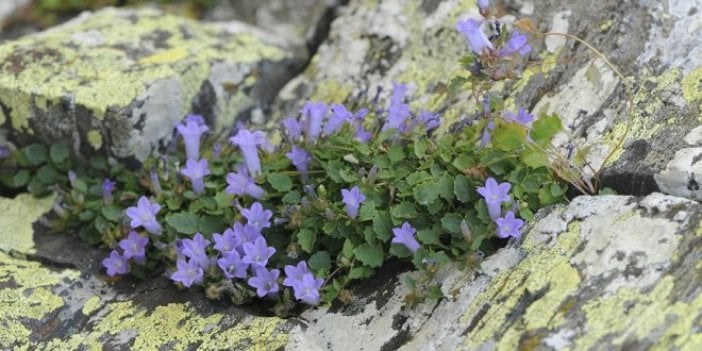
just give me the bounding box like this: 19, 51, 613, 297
288, 193, 702, 350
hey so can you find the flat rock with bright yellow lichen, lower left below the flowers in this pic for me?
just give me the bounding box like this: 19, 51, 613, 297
0, 195, 292, 350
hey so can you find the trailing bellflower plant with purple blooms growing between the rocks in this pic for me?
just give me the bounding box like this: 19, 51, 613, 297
0, 1, 632, 315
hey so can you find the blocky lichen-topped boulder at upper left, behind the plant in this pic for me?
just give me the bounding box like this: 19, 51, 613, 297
0, 8, 306, 160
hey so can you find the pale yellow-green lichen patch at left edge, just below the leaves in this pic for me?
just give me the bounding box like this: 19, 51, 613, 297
0, 194, 54, 253
